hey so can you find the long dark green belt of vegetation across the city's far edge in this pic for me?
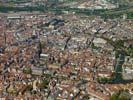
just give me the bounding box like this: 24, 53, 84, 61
0, 0, 133, 19
